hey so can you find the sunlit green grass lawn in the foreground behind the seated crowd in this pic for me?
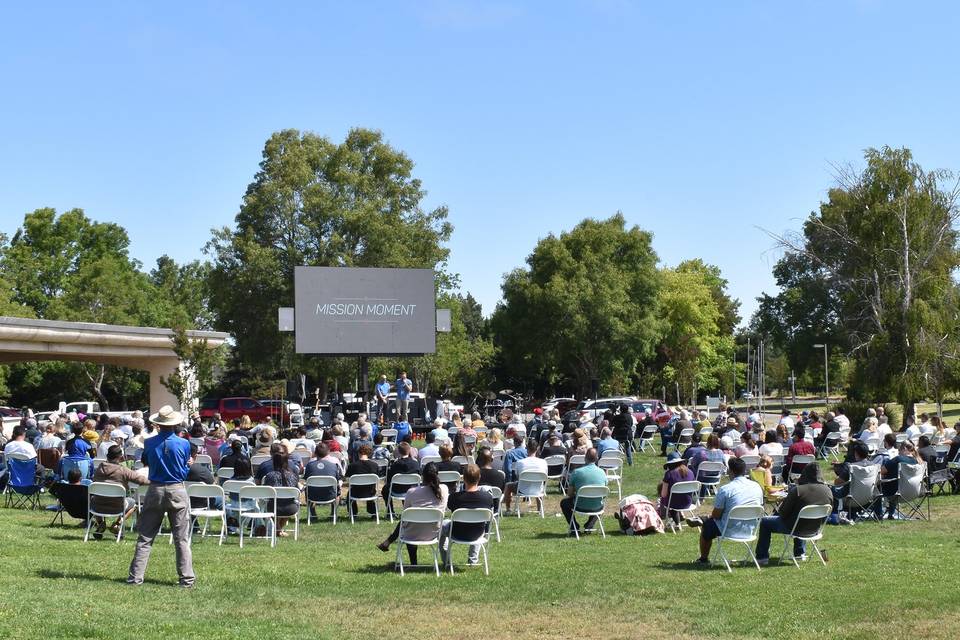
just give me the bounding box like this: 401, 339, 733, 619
0, 454, 960, 640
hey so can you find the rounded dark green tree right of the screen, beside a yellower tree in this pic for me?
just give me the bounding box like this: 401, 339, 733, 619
492, 213, 659, 394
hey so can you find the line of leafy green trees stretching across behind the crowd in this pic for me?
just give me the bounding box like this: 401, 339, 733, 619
0, 134, 957, 416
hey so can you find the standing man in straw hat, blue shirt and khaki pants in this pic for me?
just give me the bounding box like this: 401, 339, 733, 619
127, 405, 196, 588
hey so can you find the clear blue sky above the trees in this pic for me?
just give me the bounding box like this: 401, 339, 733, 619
0, 0, 960, 324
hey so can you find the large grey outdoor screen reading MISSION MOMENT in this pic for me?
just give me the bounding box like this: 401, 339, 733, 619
293, 267, 436, 355
